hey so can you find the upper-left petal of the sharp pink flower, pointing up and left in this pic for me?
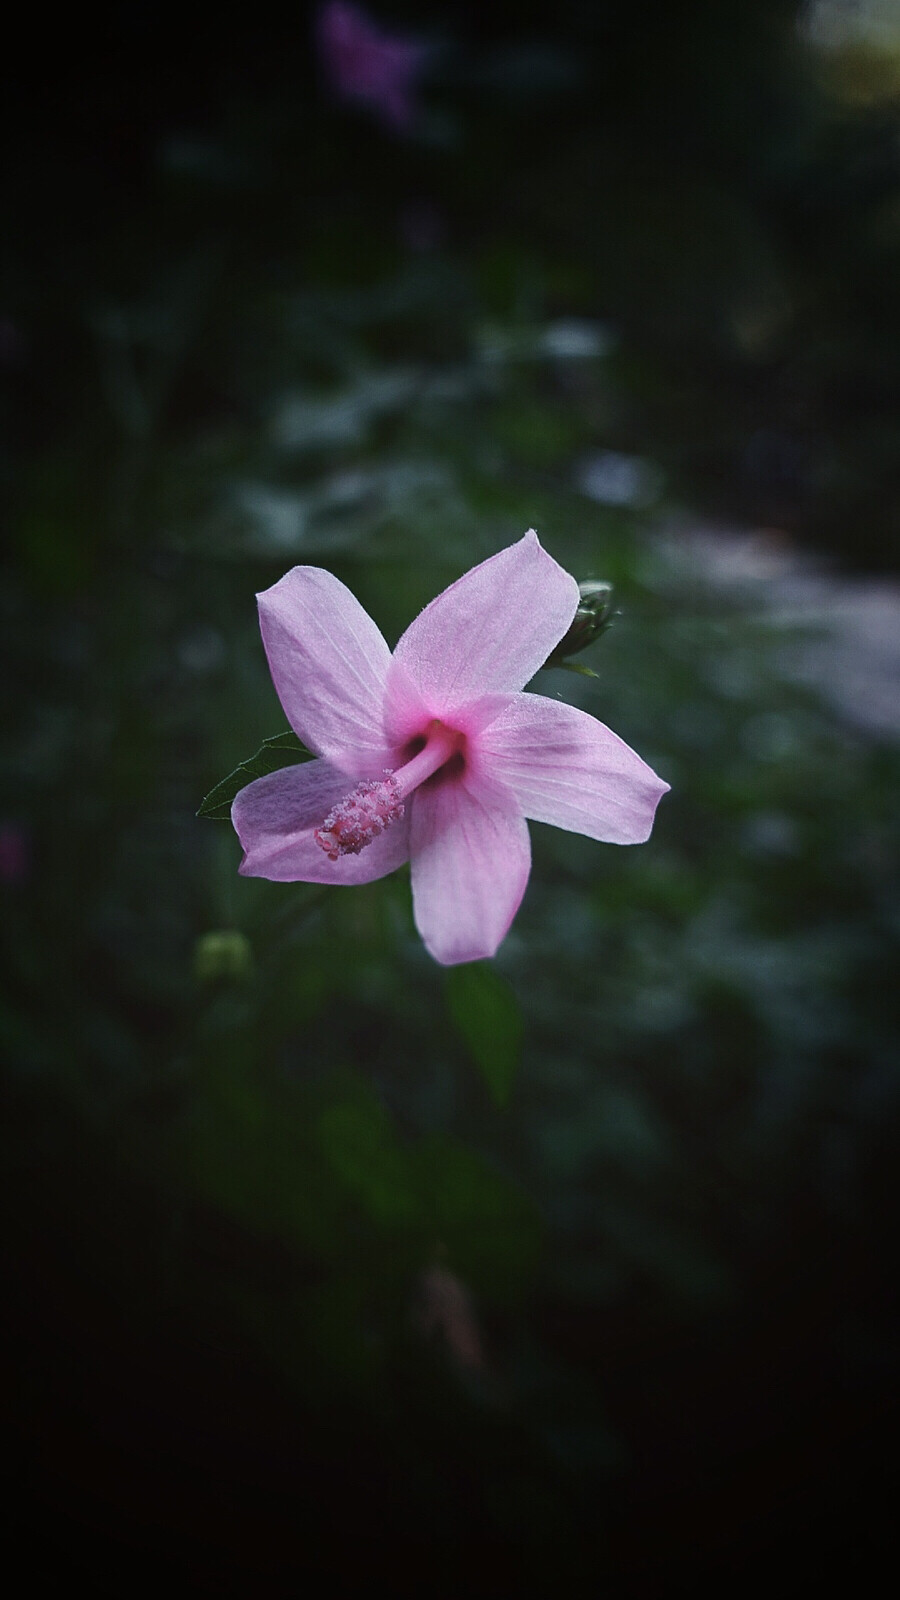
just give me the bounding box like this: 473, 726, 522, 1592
258, 566, 391, 778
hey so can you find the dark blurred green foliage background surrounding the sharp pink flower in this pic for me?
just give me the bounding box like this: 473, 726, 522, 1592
0, 0, 900, 1595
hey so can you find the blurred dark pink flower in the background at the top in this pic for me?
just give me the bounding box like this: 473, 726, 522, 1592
319, 0, 429, 133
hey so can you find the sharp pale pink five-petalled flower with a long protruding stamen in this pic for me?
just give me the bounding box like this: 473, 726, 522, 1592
231, 531, 668, 965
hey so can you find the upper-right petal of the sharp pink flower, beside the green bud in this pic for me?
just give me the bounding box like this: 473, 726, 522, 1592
394, 530, 578, 717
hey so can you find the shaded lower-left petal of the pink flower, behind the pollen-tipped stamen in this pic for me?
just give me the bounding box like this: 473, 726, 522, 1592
231, 762, 410, 883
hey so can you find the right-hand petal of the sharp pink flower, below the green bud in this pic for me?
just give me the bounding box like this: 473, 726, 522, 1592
479, 694, 669, 845
